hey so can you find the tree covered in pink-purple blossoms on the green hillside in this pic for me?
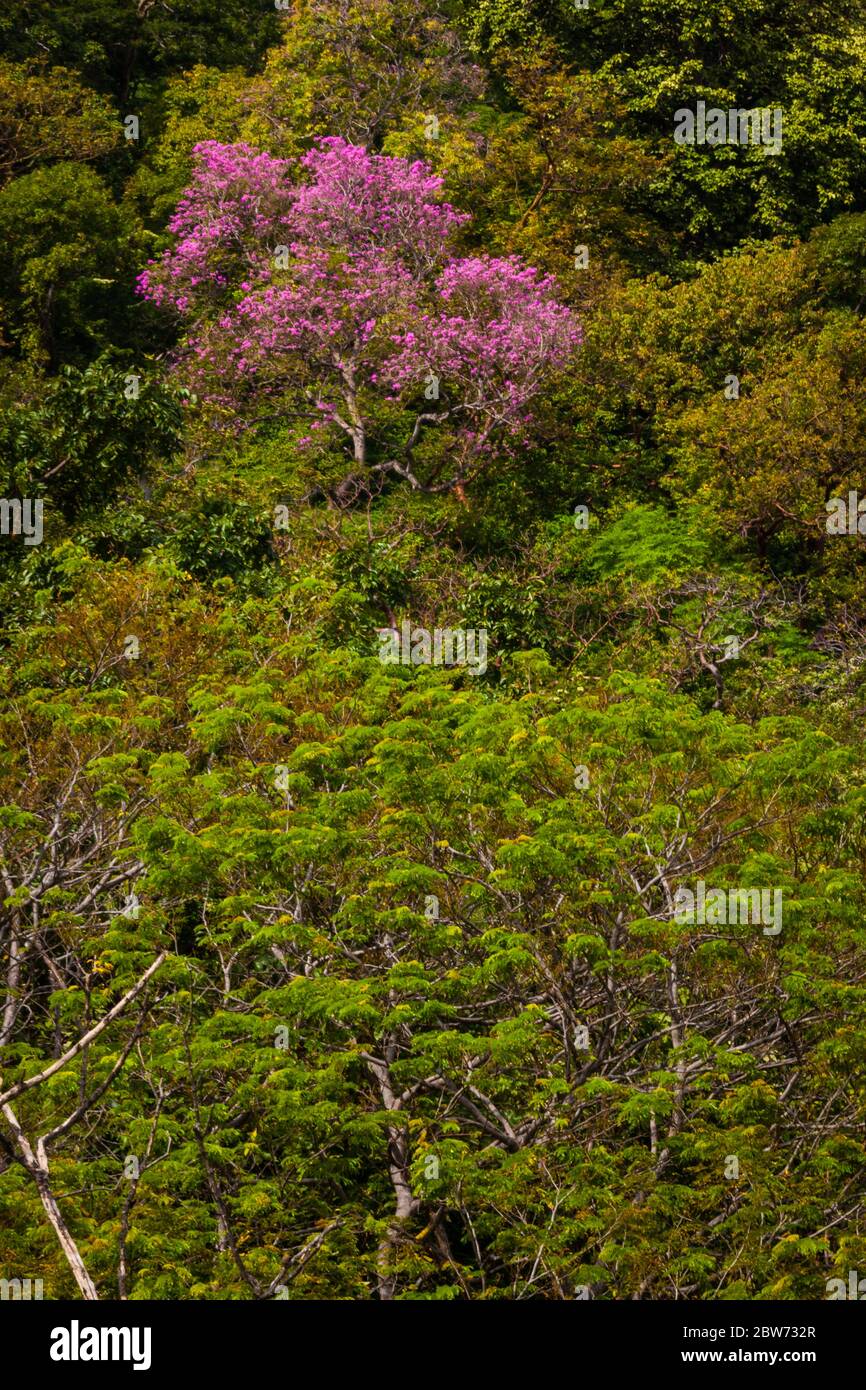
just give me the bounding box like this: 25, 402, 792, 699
140, 138, 580, 500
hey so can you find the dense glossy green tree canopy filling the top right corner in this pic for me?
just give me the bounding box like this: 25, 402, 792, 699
467, 0, 866, 262
